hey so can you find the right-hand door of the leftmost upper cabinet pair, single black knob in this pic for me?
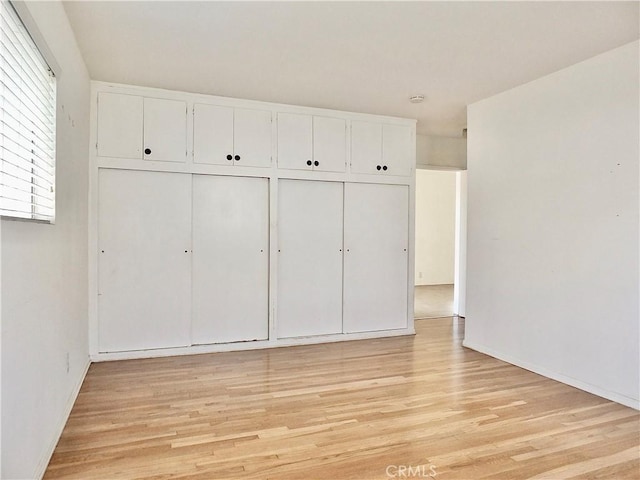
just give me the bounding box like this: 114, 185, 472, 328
144, 98, 187, 162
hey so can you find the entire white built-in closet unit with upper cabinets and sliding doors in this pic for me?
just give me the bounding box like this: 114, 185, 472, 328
90, 82, 415, 360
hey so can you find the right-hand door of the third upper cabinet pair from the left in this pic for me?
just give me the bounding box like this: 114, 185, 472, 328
313, 117, 346, 172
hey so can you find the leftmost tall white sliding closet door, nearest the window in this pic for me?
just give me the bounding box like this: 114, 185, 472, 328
98, 169, 191, 352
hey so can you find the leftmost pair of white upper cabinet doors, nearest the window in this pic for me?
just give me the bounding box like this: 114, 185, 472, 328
97, 92, 187, 162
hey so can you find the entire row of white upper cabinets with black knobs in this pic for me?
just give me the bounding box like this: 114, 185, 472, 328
96, 87, 415, 176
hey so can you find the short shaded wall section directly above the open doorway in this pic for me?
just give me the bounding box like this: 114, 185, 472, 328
416, 135, 467, 170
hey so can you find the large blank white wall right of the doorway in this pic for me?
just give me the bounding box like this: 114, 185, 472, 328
464, 42, 640, 408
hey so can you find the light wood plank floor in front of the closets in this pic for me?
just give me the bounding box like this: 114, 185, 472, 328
46, 319, 640, 480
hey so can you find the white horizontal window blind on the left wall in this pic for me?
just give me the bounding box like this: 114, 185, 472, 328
0, 0, 56, 222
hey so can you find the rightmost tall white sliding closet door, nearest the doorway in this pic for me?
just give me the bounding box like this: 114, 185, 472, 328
344, 183, 409, 333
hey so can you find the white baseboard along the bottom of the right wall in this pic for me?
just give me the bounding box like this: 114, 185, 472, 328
462, 339, 640, 410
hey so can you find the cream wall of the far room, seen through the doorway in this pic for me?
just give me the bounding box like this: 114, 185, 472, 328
415, 169, 456, 285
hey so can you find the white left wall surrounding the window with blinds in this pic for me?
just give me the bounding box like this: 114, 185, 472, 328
1, 2, 89, 479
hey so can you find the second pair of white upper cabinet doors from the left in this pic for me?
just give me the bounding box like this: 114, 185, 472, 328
193, 104, 271, 167
